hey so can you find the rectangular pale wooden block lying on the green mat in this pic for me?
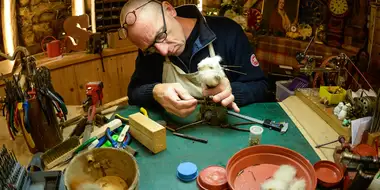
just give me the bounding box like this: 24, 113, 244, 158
129, 113, 166, 154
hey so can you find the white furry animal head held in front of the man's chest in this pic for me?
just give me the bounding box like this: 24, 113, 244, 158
198, 55, 226, 88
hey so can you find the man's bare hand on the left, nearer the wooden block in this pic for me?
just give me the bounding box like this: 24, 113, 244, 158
153, 83, 198, 117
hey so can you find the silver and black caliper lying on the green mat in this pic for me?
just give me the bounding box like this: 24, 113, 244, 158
227, 111, 288, 133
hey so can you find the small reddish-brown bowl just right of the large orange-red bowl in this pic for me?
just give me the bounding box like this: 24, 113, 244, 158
314, 160, 344, 188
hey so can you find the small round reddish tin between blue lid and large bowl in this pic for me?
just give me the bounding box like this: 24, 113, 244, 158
197, 166, 228, 190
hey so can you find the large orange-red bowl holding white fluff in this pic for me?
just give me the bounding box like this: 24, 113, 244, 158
226, 145, 317, 190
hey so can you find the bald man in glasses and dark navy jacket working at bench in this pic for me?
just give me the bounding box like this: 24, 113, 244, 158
119, 0, 267, 117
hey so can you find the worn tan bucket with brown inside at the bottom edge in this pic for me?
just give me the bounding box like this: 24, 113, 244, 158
65, 148, 140, 190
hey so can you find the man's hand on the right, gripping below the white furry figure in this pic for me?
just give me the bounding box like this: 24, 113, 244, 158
203, 77, 240, 112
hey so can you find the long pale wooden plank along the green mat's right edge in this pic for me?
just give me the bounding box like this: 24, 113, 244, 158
282, 96, 340, 161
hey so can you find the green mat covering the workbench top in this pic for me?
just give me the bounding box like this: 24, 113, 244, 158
113, 103, 319, 190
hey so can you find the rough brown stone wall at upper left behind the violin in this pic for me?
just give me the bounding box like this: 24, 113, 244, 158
17, 0, 71, 54
